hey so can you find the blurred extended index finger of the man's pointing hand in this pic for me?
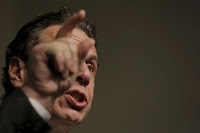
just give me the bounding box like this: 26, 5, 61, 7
56, 10, 86, 38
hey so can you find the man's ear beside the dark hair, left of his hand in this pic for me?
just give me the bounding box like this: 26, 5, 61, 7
8, 57, 26, 88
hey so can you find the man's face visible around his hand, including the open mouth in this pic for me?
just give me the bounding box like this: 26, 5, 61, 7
41, 25, 98, 125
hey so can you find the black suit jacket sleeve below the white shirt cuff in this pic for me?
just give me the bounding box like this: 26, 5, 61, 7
0, 89, 50, 133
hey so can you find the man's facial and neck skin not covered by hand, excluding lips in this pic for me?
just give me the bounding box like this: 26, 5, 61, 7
45, 26, 98, 133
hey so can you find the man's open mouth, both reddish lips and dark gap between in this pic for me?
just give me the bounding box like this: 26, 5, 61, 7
66, 90, 87, 110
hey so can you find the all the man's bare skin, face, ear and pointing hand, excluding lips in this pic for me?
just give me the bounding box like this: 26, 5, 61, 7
9, 11, 98, 133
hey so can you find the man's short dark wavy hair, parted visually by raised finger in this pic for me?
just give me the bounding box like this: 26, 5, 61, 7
2, 7, 96, 94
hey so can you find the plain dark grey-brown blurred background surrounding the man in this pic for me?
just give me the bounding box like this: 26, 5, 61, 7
0, 0, 200, 133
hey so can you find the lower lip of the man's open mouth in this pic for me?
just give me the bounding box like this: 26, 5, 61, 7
66, 94, 87, 109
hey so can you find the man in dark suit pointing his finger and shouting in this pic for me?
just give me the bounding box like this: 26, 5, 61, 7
0, 8, 98, 132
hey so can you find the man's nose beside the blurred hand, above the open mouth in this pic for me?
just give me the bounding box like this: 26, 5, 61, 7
76, 62, 91, 86
